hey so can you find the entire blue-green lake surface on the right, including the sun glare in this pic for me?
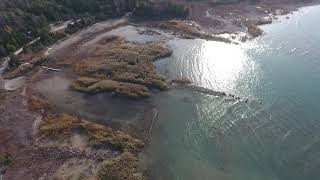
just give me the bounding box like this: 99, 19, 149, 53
144, 6, 320, 180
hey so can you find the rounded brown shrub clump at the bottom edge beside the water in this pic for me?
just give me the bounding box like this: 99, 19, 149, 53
97, 152, 145, 180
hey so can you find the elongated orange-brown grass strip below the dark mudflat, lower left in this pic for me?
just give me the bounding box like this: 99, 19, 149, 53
39, 114, 144, 153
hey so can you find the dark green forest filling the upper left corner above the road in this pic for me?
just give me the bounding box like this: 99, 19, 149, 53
0, 0, 141, 57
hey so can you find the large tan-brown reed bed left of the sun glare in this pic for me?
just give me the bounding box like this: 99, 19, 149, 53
73, 36, 172, 98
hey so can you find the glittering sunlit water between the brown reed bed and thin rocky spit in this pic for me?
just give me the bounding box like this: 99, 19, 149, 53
156, 39, 268, 98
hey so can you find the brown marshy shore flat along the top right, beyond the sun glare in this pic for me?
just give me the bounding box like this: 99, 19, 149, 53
136, 1, 320, 44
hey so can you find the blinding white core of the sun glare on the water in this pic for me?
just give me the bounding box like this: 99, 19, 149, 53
197, 41, 248, 92
